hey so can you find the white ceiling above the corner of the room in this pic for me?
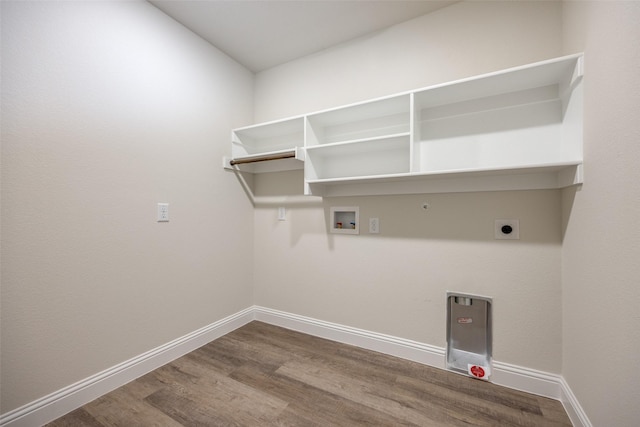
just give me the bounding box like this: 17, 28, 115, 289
149, 0, 459, 72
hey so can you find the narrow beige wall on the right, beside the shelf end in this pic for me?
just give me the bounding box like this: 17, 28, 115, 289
562, 1, 640, 426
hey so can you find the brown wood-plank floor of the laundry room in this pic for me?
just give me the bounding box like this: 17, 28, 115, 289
48, 322, 571, 427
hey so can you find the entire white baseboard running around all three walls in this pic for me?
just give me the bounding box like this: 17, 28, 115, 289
0, 306, 592, 427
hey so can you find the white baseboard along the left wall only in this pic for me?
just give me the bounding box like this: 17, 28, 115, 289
0, 307, 253, 427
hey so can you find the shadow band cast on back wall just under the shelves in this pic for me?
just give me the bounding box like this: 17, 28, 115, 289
231, 171, 564, 248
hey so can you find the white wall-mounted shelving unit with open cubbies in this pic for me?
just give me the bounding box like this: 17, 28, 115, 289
226, 54, 583, 196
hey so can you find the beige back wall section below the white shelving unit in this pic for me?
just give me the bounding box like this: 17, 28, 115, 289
255, 183, 561, 372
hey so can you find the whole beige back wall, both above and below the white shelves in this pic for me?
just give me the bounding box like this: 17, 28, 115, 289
255, 2, 562, 373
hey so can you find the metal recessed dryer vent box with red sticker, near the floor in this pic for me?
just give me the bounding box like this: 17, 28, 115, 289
447, 292, 492, 380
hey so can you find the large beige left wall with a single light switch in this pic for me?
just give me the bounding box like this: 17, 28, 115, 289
0, 1, 253, 413
